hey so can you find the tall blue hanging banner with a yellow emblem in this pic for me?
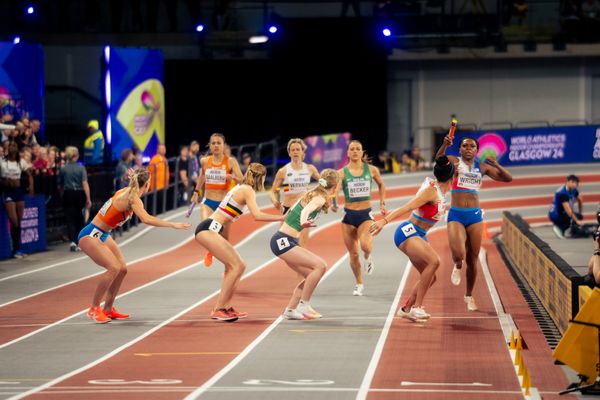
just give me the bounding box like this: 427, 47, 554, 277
104, 47, 165, 160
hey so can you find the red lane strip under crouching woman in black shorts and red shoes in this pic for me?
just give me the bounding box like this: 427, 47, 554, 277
30, 225, 346, 399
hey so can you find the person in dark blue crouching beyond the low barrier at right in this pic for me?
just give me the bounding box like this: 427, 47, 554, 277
548, 175, 583, 238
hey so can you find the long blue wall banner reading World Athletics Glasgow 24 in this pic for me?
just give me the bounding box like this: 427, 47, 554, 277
447, 125, 600, 166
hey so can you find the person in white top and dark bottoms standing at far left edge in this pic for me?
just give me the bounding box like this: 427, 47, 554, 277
0, 141, 33, 258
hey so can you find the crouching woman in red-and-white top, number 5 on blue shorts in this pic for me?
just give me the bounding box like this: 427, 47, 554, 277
369, 156, 454, 322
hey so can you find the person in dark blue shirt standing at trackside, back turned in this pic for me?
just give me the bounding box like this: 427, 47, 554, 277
59, 146, 92, 251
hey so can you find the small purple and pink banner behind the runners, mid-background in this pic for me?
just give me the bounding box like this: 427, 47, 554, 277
304, 132, 352, 171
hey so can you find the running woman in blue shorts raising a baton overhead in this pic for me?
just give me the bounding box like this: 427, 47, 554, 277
436, 135, 512, 311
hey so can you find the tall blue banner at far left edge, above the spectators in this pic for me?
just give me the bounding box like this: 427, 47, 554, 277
0, 42, 44, 141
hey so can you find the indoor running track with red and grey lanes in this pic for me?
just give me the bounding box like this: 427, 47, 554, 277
0, 164, 600, 399
